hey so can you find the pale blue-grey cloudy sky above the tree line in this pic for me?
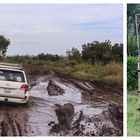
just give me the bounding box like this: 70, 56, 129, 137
0, 4, 123, 55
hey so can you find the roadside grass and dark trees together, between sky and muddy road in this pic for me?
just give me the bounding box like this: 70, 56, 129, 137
0, 40, 123, 87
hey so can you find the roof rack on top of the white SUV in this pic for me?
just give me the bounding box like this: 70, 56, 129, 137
0, 62, 23, 70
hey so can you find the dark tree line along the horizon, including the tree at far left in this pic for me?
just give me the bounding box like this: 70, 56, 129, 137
0, 35, 123, 64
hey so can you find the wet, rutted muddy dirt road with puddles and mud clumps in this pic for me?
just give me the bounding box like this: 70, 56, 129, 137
0, 68, 123, 136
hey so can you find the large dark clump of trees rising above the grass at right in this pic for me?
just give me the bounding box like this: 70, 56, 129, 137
82, 40, 123, 64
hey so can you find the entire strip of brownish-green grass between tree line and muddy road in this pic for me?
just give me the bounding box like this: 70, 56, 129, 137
5, 58, 123, 87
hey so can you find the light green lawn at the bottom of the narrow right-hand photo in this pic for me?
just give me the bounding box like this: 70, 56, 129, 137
127, 91, 140, 136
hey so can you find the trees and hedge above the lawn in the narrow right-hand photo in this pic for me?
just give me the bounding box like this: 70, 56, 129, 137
127, 4, 140, 90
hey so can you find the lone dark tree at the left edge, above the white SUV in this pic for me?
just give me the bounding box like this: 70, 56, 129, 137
0, 35, 10, 56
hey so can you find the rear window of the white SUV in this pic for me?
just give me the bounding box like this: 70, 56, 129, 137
0, 69, 25, 82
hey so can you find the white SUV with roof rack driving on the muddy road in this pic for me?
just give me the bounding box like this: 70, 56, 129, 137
0, 63, 29, 103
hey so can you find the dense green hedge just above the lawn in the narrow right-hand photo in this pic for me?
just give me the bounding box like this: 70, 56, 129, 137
127, 56, 138, 90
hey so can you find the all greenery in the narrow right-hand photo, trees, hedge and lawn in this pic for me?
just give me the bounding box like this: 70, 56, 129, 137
127, 4, 140, 136
